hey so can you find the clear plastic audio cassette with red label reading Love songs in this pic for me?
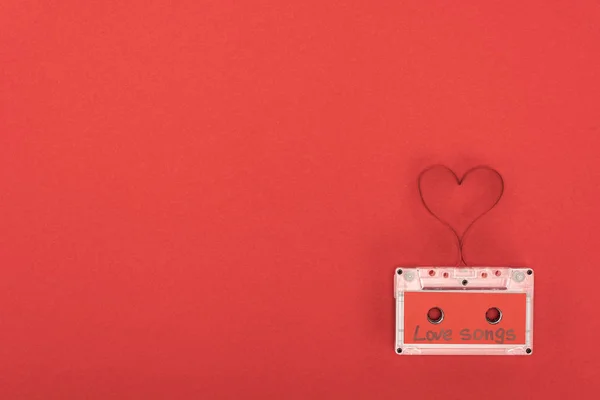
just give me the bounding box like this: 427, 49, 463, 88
394, 267, 534, 355
